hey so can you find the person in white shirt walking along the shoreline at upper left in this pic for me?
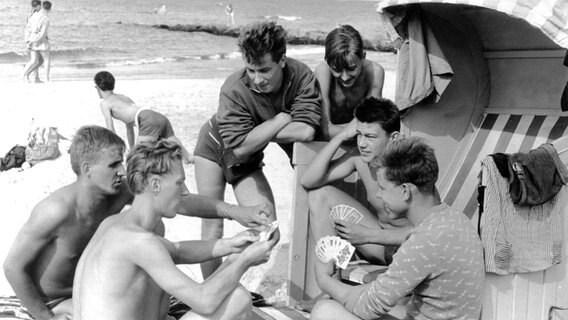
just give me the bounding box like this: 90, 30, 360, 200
24, 1, 51, 82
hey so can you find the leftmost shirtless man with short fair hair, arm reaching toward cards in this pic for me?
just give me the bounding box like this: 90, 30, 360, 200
4, 126, 270, 320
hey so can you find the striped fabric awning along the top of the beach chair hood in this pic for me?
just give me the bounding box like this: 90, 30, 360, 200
377, 0, 568, 48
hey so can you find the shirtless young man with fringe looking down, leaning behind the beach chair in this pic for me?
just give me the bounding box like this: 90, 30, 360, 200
315, 24, 385, 141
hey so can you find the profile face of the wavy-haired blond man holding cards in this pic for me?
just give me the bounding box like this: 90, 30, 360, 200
158, 160, 189, 218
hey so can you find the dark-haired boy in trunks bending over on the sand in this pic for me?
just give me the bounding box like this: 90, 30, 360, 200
95, 71, 193, 163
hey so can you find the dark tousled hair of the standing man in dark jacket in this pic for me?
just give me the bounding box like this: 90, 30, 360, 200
238, 21, 286, 64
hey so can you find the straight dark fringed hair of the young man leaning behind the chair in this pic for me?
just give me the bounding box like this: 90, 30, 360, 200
324, 24, 364, 70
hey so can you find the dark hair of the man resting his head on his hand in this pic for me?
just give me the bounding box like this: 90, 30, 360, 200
354, 97, 400, 134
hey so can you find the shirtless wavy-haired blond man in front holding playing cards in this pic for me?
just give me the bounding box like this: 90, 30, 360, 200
73, 140, 276, 320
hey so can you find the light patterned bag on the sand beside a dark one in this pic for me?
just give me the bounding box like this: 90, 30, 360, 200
26, 127, 61, 166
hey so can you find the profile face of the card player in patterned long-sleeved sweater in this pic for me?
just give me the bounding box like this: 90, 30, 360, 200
375, 168, 410, 219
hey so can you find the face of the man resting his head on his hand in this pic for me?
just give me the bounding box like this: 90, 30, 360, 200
356, 121, 390, 163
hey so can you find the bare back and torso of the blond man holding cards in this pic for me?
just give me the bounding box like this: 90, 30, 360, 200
73, 214, 173, 320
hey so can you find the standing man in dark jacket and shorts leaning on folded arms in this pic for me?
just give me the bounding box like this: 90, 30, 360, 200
194, 22, 321, 278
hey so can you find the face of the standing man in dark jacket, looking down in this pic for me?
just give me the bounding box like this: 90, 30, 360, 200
243, 53, 286, 93
